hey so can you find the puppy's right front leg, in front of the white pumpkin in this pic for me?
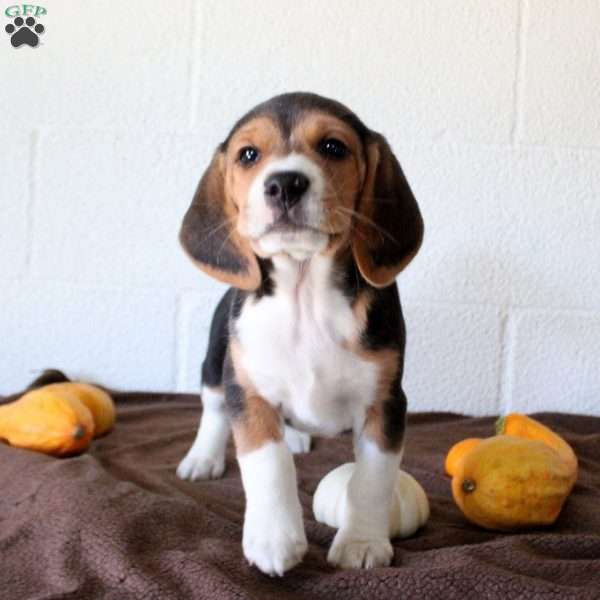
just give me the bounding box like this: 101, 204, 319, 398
327, 390, 404, 569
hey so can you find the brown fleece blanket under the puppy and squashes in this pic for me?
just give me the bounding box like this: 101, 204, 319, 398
0, 394, 600, 600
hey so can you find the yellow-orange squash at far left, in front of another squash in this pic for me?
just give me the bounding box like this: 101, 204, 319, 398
0, 386, 94, 456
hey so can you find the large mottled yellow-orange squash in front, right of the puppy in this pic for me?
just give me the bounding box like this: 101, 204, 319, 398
452, 435, 576, 530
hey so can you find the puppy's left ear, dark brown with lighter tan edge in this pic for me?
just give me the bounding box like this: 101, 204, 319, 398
179, 150, 261, 291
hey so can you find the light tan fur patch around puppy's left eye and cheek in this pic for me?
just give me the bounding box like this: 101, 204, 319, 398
225, 116, 285, 235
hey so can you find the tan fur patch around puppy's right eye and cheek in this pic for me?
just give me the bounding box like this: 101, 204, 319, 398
290, 111, 366, 234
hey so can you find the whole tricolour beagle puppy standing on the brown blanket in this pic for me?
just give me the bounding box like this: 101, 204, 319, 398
177, 93, 423, 575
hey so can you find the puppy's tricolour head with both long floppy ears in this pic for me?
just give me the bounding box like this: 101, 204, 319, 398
180, 93, 423, 290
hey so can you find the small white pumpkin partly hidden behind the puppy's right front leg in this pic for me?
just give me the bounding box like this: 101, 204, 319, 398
313, 463, 429, 538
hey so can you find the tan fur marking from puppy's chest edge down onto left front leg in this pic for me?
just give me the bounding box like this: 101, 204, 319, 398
230, 338, 283, 456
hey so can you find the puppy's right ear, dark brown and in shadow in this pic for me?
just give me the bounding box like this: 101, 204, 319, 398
352, 132, 423, 287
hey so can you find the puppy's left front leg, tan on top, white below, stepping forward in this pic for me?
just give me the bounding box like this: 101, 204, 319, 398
233, 396, 307, 575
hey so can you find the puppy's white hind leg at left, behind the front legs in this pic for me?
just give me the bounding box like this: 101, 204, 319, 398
177, 386, 231, 480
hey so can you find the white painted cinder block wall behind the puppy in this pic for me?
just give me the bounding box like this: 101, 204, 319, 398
0, 0, 600, 414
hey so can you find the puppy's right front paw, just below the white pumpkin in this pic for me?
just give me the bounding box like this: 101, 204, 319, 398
327, 530, 394, 569
